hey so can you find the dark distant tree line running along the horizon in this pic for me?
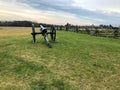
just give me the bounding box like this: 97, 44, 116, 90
0, 21, 119, 29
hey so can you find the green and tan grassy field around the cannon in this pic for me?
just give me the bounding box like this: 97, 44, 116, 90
0, 27, 120, 90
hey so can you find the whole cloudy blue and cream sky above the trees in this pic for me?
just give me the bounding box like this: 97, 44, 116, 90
0, 0, 120, 25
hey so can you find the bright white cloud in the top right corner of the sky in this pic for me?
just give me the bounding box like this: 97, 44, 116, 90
74, 0, 120, 13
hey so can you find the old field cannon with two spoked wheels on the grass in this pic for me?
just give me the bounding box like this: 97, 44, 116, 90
31, 24, 56, 48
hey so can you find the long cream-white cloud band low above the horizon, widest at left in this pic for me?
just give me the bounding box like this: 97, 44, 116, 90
0, 0, 93, 24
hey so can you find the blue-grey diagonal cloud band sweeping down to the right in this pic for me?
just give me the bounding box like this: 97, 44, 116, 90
22, 0, 120, 24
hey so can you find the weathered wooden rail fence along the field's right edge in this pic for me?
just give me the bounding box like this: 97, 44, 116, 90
55, 26, 120, 38
